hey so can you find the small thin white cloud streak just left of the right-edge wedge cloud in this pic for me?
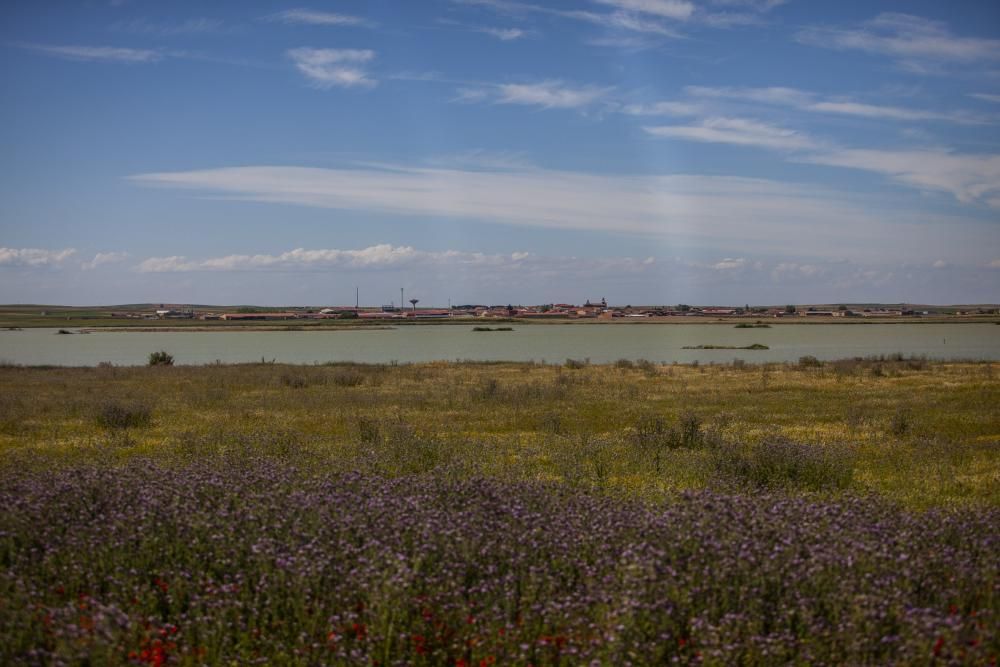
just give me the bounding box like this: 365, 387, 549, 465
643, 117, 818, 151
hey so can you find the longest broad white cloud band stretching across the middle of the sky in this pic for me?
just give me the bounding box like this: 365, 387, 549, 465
125, 165, 998, 263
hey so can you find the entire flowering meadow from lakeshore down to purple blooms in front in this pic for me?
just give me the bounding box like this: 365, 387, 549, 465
0, 357, 1000, 665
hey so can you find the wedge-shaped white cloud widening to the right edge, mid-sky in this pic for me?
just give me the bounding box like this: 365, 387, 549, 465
802, 149, 1000, 209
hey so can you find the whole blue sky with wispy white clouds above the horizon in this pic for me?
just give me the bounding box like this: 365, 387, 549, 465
0, 0, 1000, 305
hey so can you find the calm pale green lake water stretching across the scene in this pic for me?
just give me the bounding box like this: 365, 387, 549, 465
0, 324, 1000, 366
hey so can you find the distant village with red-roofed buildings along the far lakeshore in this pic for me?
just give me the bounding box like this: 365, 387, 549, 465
112, 298, 964, 321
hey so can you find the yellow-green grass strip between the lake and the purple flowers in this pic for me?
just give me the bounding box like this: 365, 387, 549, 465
0, 359, 1000, 508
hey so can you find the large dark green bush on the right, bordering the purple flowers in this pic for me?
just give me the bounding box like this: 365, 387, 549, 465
714, 437, 854, 491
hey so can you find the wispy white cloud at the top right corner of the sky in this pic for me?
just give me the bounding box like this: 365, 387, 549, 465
797, 13, 1000, 63
